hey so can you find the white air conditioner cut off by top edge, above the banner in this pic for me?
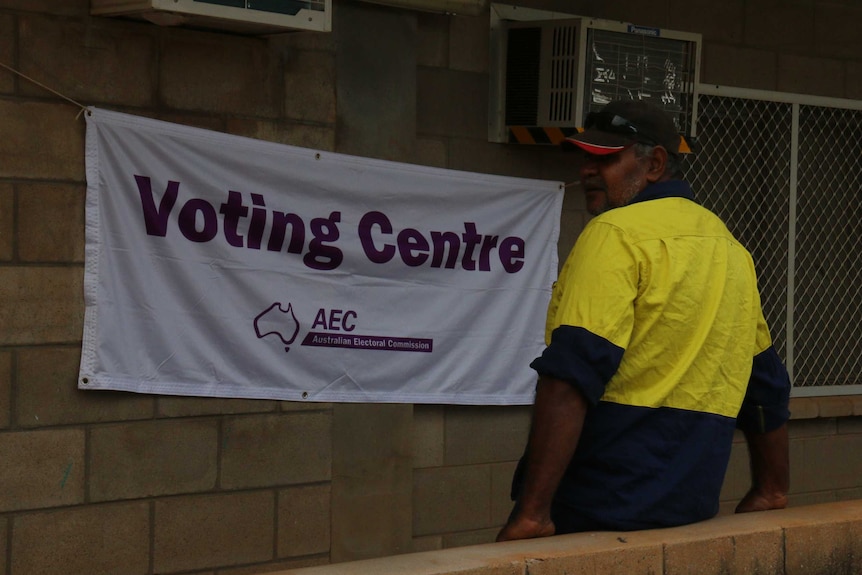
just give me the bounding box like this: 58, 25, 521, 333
90, 0, 332, 35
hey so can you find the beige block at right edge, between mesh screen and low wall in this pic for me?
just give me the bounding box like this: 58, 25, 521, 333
791, 434, 862, 491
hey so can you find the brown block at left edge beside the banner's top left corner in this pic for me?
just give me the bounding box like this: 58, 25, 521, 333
0, 100, 84, 181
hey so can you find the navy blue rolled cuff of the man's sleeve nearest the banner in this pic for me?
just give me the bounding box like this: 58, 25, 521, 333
530, 325, 625, 405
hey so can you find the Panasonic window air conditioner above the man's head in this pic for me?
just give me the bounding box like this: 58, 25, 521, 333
488, 4, 701, 144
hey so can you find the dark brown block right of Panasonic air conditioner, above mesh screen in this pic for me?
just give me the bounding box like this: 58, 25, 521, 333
701, 43, 778, 90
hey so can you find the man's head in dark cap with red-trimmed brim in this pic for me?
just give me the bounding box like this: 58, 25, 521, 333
563, 100, 680, 215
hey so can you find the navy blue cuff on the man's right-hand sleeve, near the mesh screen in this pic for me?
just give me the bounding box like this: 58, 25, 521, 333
736, 346, 790, 433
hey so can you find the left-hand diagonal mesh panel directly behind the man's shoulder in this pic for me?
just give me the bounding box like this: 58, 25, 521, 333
685, 95, 792, 364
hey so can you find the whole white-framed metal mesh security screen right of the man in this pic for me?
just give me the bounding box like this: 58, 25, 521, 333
686, 86, 862, 396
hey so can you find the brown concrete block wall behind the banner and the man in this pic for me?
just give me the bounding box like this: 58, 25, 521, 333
0, 0, 862, 575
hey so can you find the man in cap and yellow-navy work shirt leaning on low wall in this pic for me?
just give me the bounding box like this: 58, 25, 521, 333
497, 101, 790, 541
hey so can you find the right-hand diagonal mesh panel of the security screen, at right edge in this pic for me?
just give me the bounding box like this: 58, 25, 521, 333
794, 106, 862, 386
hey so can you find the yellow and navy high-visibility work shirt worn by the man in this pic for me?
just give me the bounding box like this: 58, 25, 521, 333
531, 180, 790, 529
